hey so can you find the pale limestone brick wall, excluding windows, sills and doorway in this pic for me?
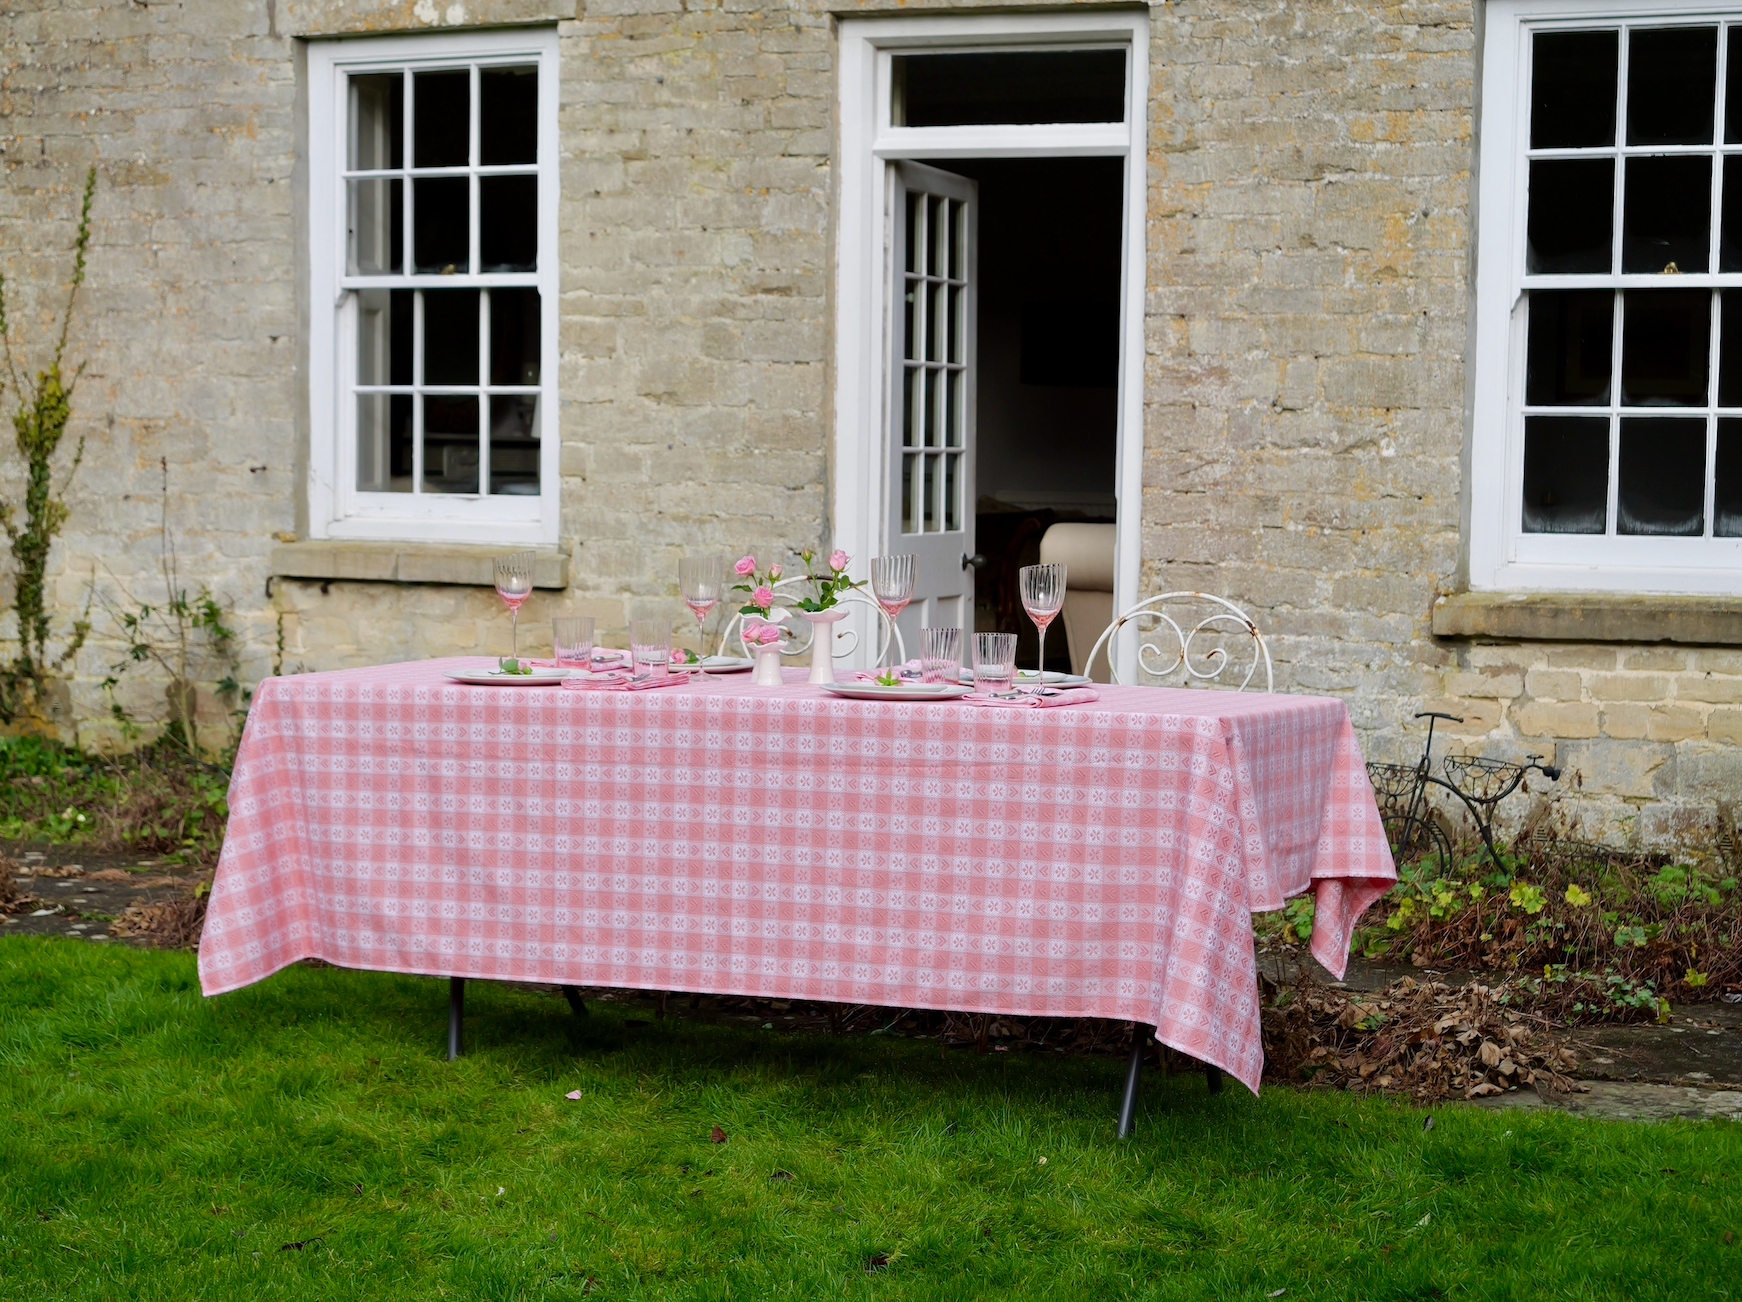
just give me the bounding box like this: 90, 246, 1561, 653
0, 0, 1742, 854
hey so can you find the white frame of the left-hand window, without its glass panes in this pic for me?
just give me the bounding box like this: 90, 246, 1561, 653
308, 28, 561, 544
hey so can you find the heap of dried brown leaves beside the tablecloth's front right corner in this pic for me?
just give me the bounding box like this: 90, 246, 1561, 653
1263, 976, 1583, 1102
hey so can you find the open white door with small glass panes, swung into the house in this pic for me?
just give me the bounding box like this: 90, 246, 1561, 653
885, 162, 979, 655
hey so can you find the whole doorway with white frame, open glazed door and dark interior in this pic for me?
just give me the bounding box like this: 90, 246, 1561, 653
834, 14, 1146, 668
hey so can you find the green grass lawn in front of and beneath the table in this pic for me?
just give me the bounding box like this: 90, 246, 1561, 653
0, 938, 1742, 1302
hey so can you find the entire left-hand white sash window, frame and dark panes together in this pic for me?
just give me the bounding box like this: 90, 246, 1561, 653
308, 30, 557, 542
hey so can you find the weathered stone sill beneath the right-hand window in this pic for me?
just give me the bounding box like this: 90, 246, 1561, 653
1434, 593, 1742, 647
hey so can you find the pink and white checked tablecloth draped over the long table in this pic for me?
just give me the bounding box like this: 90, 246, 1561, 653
200, 659, 1395, 1091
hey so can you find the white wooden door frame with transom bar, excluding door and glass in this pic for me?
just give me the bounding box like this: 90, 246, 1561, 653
831, 10, 1150, 676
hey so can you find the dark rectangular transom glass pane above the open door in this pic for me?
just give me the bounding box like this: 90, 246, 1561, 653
890, 51, 1125, 127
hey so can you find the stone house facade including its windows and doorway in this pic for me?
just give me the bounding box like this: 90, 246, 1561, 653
0, 0, 1742, 845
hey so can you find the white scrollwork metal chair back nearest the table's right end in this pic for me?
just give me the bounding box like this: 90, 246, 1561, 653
1084, 593, 1275, 692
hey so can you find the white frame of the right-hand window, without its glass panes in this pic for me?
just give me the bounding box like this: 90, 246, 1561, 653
1469, 0, 1742, 594
